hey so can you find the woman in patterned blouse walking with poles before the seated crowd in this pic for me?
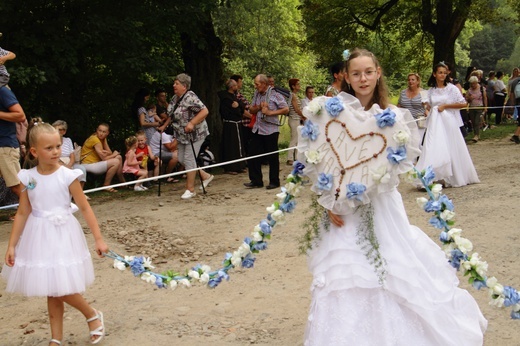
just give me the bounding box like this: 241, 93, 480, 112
168, 73, 214, 199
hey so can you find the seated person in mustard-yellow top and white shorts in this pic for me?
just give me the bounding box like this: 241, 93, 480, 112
81, 123, 125, 192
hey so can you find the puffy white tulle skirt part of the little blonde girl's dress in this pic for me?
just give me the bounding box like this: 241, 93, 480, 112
2, 213, 94, 297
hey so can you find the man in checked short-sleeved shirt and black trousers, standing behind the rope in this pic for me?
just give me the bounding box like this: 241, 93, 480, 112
244, 74, 289, 190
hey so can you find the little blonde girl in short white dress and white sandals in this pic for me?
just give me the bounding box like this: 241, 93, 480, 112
2, 123, 108, 345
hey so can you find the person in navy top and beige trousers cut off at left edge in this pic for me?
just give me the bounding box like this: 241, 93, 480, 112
0, 86, 25, 197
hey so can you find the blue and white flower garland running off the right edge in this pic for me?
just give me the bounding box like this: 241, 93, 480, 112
409, 167, 520, 319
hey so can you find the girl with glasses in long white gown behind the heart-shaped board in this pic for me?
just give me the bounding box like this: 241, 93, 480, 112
300, 49, 487, 346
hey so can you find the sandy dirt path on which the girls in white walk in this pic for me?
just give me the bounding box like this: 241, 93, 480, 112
0, 139, 520, 346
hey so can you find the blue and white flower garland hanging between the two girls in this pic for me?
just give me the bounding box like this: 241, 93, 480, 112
105, 166, 305, 290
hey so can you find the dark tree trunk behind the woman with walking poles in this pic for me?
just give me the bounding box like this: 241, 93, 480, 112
181, 14, 224, 161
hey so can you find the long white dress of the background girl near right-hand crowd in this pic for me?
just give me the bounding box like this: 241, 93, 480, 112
416, 83, 480, 187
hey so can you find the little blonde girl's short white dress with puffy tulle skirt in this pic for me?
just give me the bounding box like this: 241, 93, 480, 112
2, 167, 94, 297
